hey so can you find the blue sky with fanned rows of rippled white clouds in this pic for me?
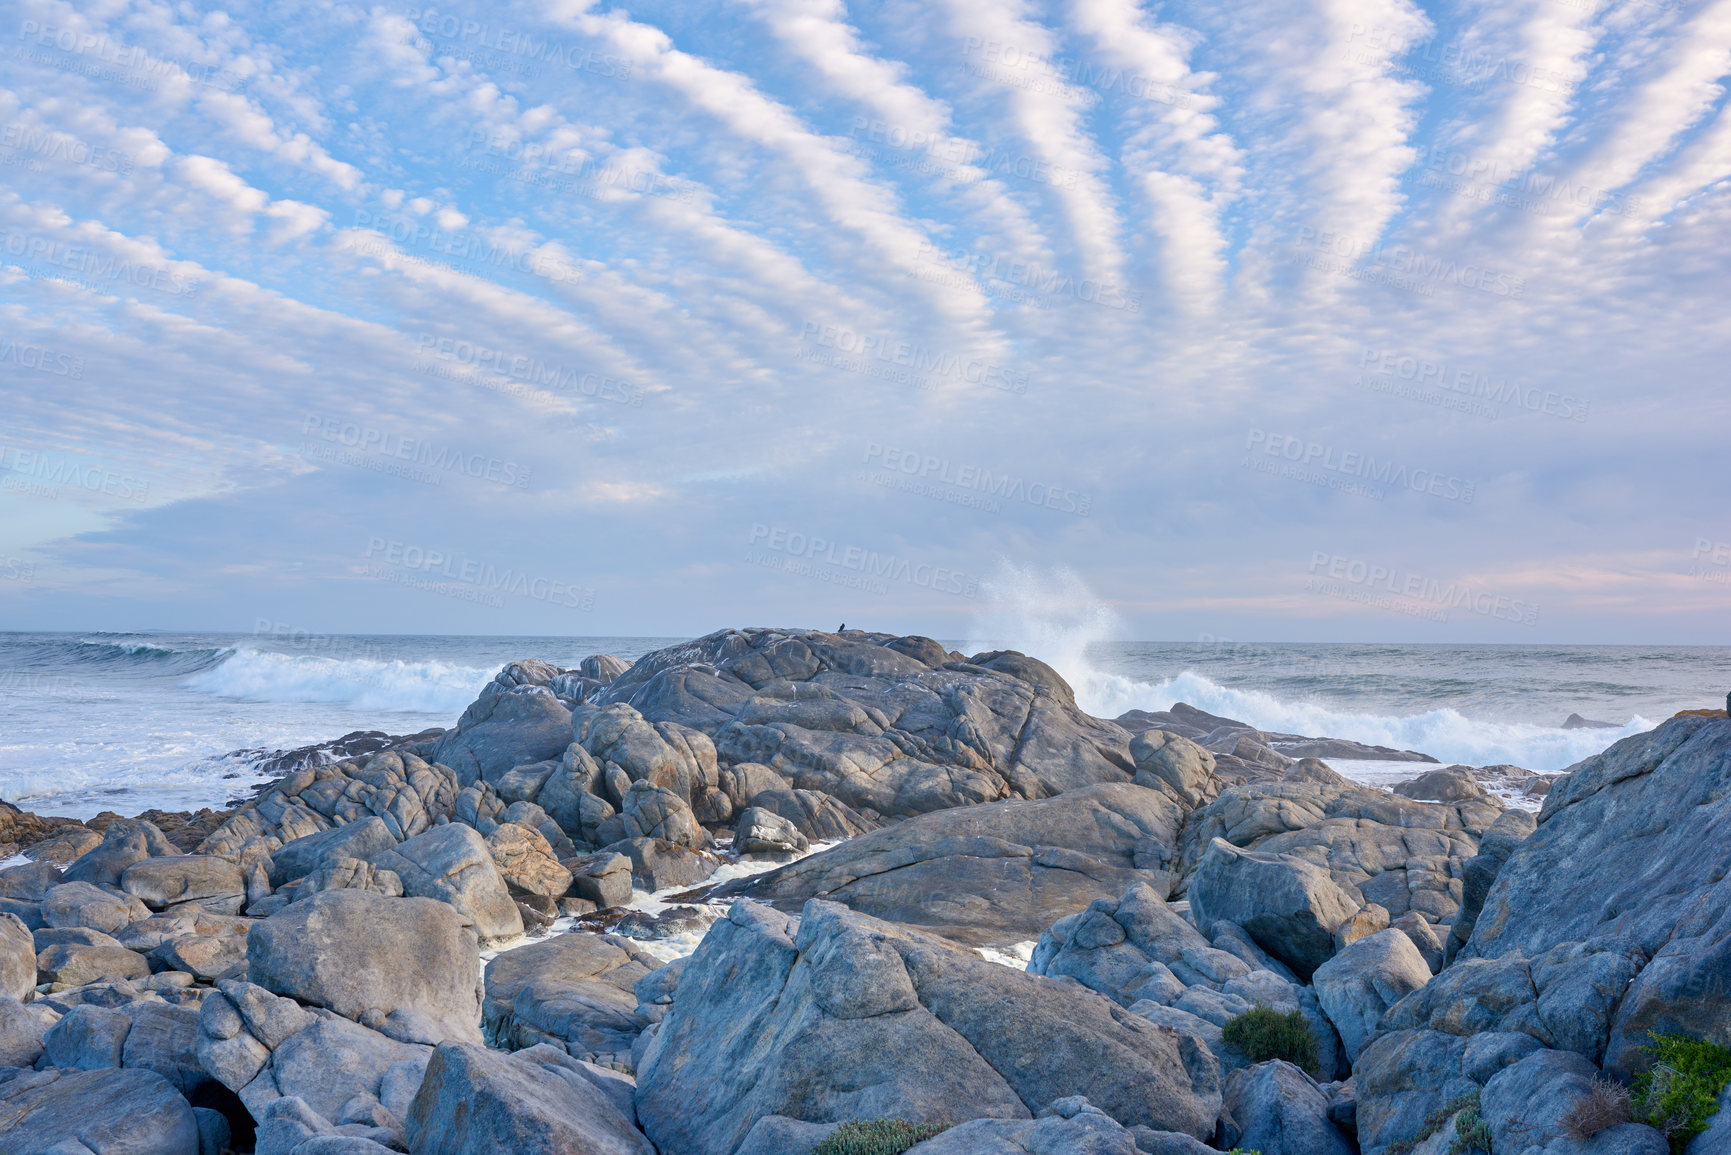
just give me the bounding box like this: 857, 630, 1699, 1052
0, 0, 1731, 644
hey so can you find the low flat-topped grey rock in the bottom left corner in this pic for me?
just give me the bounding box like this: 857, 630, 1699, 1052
0, 1070, 199, 1155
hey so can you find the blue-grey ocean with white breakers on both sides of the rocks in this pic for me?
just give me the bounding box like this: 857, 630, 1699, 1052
0, 630, 1731, 817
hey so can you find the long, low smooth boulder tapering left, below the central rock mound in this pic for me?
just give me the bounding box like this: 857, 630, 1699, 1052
718, 783, 1182, 947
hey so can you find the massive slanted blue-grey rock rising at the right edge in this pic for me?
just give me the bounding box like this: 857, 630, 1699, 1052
1461, 715, 1731, 1075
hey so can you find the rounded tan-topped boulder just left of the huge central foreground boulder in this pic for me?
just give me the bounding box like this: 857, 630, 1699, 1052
483, 932, 661, 1067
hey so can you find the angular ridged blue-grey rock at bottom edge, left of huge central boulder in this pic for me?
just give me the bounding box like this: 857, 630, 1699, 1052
403, 1042, 654, 1155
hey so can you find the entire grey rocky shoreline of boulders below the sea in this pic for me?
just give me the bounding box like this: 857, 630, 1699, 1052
0, 629, 1731, 1155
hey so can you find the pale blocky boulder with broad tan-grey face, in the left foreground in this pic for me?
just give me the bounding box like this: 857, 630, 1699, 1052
246, 890, 481, 1042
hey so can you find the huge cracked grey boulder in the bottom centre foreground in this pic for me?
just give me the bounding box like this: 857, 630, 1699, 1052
637, 900, 1220, 1155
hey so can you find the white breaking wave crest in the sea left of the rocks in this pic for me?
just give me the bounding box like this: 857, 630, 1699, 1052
185, 649, 493, 715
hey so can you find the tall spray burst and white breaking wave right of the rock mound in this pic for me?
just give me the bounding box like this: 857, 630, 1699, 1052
968, 563, 1655, 771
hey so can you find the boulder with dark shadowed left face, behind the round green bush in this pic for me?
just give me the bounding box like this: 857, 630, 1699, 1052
1189, 838, 1361, 978
